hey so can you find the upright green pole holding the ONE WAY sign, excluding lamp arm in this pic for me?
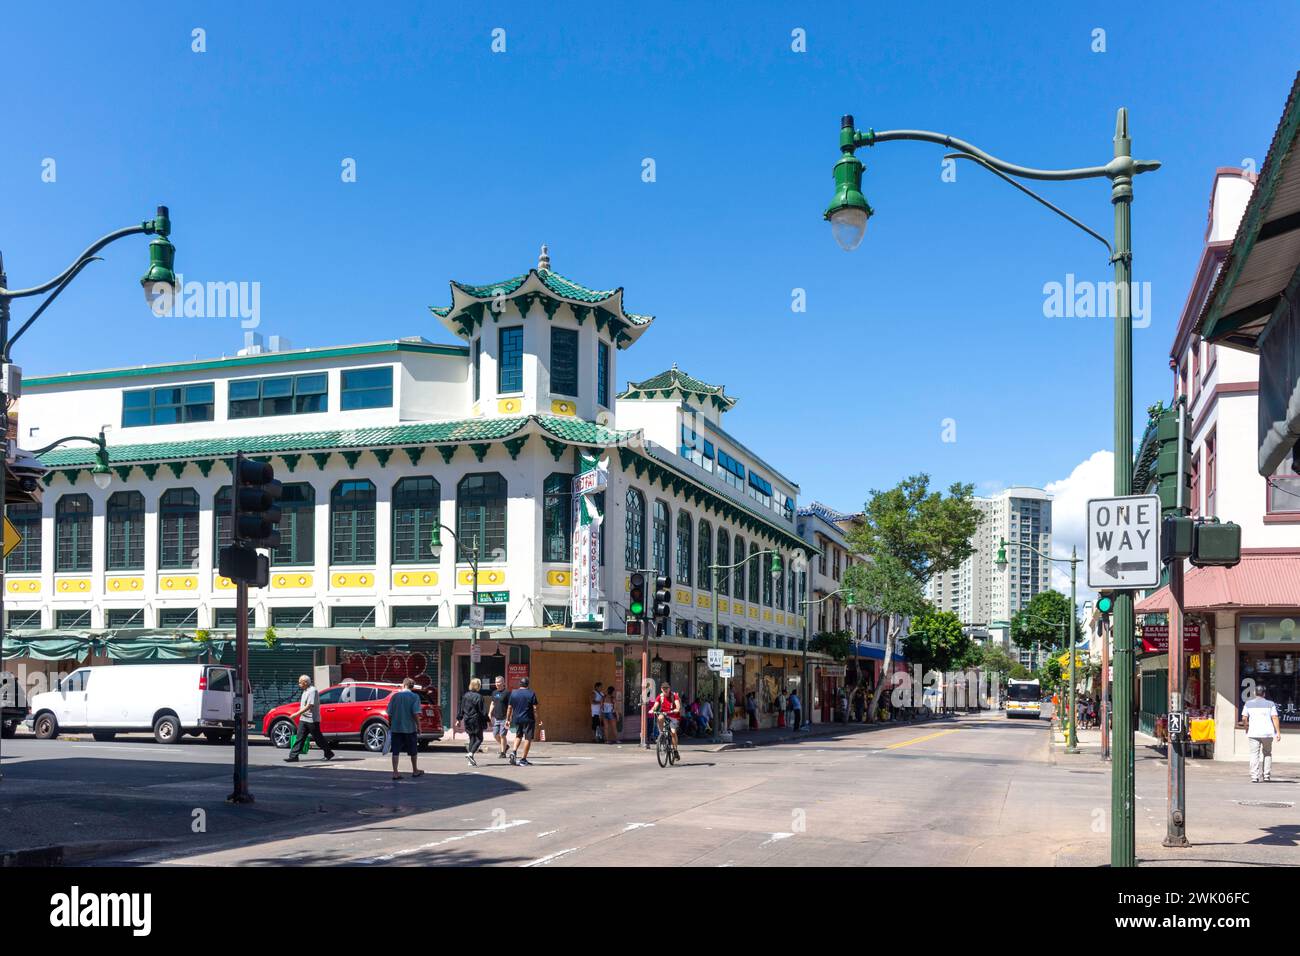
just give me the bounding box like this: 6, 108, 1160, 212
1110, 108, 1136, 866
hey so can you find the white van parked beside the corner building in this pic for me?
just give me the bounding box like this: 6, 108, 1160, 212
30, 663, 247, 744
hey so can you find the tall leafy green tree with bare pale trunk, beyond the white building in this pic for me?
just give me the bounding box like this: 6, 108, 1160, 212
844, 473, 980, 719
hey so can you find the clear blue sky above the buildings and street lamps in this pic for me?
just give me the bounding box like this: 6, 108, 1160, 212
0, 3, 1300, 538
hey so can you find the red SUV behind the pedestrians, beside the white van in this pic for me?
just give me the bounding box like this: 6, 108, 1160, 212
261, 680, 442, 753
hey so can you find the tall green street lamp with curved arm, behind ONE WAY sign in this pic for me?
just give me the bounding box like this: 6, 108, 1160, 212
824, 107, 1160, 866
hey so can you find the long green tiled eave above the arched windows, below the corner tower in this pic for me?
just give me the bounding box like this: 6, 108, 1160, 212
40, 415, 644, 468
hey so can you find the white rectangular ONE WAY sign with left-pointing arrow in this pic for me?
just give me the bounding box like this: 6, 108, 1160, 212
1088, 494, 1160, 591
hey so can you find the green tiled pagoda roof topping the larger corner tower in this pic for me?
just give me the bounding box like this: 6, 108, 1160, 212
429, 260, 654, 349
